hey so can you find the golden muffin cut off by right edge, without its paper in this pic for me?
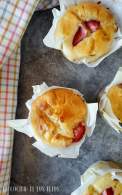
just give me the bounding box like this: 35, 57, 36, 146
107, 83, 122, 123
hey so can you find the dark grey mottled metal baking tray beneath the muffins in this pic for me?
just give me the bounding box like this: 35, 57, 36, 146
10, 10, 122, 195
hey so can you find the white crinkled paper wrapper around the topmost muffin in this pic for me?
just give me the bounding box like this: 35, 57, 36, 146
43, 0, 122, 67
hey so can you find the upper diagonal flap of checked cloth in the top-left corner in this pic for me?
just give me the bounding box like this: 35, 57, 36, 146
0, 0, 38, 65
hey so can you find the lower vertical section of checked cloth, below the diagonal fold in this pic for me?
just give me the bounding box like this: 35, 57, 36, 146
0, 48, 20, 195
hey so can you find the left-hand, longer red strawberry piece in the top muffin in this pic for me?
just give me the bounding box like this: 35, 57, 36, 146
72, 26, 87, 46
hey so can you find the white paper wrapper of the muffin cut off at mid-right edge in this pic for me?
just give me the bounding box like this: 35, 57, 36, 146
99, 67, 122, 133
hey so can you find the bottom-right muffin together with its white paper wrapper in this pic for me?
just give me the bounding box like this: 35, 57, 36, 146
72, 161, 122, 195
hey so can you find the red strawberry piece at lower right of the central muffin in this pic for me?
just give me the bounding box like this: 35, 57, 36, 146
73, 123, 86, 142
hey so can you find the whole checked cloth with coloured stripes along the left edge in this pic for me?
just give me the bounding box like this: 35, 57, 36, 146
0, 0, 38, 195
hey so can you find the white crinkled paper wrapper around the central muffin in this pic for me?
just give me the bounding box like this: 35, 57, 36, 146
8, 83, 98, 158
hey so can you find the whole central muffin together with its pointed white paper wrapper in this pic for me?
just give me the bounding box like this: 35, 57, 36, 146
7, 83, 98, 158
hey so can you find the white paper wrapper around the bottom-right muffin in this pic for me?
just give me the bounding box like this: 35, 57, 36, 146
71, 161, 122, 195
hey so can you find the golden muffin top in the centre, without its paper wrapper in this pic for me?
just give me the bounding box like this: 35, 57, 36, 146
29, 87, 88, 147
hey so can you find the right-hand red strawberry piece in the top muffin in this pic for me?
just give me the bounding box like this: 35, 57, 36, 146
85, 20, 100, 32
